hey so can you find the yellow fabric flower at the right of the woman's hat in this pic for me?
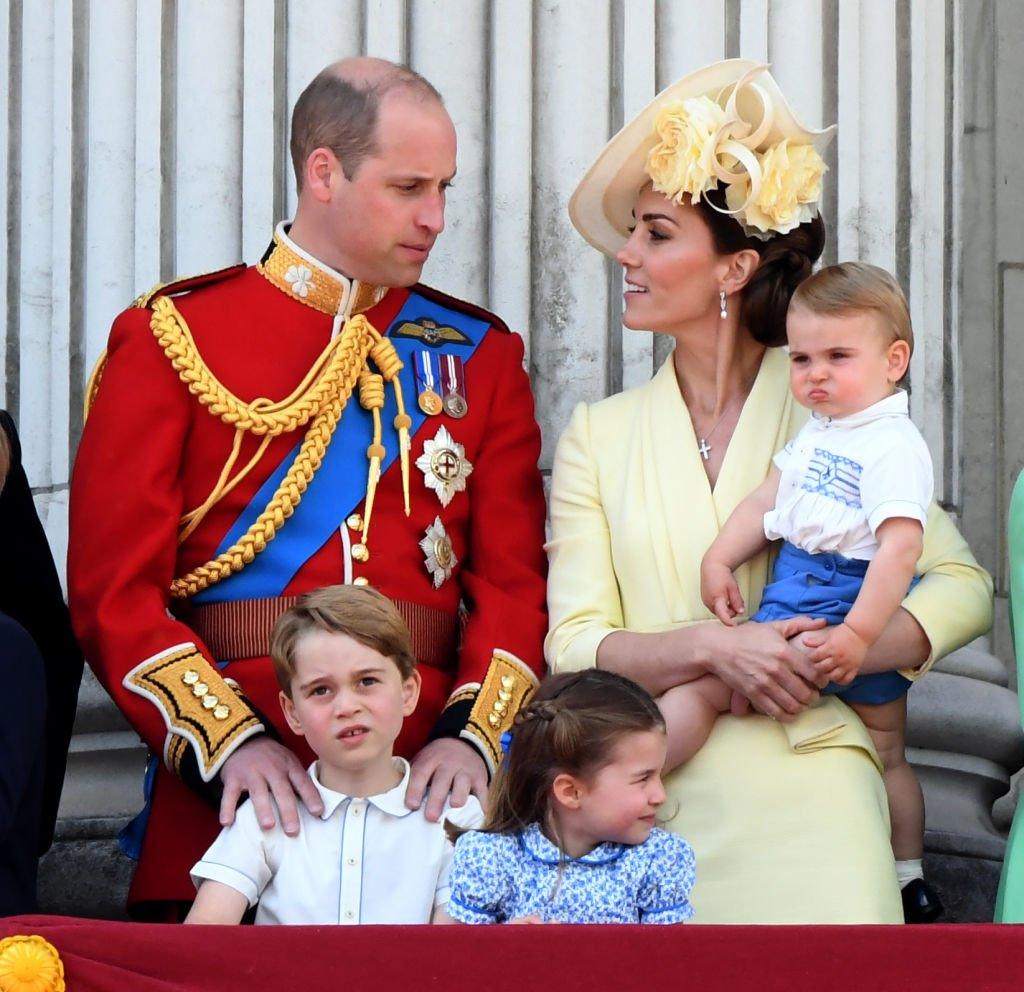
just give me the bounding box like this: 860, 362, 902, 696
725, 138, 827, 235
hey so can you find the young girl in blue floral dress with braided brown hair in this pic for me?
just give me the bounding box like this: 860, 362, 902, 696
447, 668, 694, 923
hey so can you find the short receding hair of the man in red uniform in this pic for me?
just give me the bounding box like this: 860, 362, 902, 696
291, 66, 444, 192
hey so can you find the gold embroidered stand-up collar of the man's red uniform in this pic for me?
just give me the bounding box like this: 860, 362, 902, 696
256, 223, 387, 318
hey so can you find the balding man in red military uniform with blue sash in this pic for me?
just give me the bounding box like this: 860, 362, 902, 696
69, 59, 547, 909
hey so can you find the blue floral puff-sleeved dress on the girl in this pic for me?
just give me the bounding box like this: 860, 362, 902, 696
447, 823, 696, 923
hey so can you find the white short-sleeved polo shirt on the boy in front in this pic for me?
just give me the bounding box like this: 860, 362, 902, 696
191, 758, 483, 923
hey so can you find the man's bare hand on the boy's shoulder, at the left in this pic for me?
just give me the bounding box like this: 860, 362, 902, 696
220, 737, 324, 837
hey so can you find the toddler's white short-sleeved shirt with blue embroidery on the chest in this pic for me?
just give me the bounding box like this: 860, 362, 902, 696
764, 389, 934, 560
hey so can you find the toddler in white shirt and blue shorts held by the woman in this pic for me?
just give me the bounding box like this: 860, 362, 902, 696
660, 262, 941, 919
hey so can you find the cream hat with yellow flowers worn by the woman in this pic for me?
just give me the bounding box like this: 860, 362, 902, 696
569, 58, 836, 255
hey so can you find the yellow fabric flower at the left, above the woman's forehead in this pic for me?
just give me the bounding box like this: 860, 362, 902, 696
647, 96, 726, 203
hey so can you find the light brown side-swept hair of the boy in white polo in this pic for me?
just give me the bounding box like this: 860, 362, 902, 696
270, 586, 416, 696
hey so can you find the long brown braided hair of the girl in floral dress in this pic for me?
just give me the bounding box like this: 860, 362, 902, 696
466, 668, 665, 833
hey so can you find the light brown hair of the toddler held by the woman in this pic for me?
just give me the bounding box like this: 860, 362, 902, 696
790, 262, 913, 353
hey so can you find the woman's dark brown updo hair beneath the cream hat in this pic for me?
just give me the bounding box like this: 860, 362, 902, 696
693, 185, 825, 347
